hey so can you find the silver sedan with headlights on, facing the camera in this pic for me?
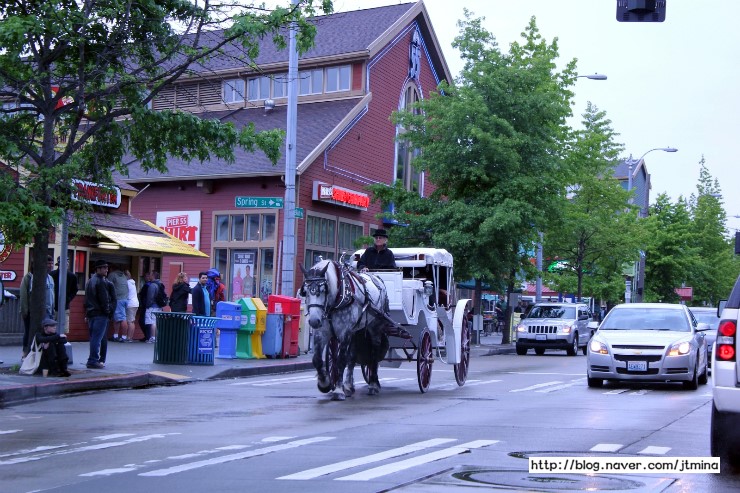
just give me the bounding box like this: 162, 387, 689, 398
586, 303, 709, 390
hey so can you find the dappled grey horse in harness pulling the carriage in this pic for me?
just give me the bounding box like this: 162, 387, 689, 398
300, 260, 393, 400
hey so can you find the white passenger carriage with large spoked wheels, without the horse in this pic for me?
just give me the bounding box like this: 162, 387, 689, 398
352, 248, 470, 392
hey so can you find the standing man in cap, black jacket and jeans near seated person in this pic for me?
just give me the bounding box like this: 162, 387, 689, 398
85, 260, 116, 369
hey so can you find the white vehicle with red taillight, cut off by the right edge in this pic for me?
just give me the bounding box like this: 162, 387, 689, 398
710, 277, 740, 469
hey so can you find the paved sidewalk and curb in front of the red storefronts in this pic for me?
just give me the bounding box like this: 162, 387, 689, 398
0, 334, 514, 408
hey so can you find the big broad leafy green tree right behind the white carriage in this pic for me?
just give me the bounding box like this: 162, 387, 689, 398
372, 10, 575, 340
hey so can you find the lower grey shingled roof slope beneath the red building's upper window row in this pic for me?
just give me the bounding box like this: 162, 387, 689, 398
123, 96, 369, 183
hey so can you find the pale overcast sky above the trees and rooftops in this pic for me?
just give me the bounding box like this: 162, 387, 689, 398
334, 0, 740, 233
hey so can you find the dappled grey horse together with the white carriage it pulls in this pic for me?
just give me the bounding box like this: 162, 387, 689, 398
301, 248, 470, 400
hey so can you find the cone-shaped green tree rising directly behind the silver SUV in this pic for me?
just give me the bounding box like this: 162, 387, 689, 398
543, 102, 643, 300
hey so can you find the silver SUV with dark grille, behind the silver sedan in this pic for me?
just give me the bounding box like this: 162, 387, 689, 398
516, 302, 591, 356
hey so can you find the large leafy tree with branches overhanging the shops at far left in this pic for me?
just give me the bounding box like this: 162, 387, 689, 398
0, 0, 332, 338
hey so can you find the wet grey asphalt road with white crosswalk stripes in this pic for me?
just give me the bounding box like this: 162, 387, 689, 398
0, 353, 740, 493
